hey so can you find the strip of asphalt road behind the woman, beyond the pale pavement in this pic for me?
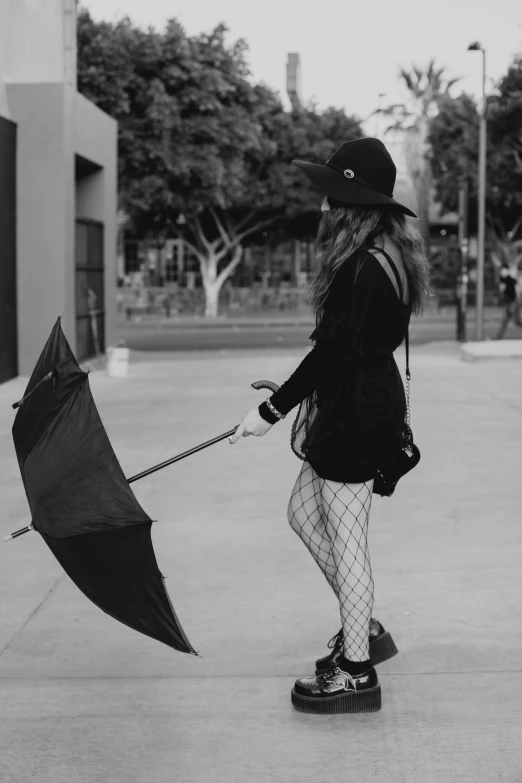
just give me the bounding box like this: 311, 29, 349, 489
117, 320, 520, 351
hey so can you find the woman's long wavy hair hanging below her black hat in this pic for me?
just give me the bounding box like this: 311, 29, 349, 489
308, 207, 430, 322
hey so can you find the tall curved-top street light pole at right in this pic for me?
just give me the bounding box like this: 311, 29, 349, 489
468, 42, 487, 340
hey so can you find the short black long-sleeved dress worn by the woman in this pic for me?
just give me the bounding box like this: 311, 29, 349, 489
270, 248, 411, 483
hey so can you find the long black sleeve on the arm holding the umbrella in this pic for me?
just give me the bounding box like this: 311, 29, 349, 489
260, 251, 380, 423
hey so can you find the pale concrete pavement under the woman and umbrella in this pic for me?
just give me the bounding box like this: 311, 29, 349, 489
0, 344, 522, 783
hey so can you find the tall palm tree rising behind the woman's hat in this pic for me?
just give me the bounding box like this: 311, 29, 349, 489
374, 59, 460, 253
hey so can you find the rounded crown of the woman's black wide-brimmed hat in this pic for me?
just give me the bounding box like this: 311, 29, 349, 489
326, 138, 397, 197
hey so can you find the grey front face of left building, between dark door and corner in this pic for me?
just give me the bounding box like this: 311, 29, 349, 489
8, 84, 69, 375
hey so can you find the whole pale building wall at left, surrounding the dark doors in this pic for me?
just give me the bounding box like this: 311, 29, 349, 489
0, 0, 117, 375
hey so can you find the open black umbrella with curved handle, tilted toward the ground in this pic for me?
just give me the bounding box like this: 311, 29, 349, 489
4, 317, 277, 655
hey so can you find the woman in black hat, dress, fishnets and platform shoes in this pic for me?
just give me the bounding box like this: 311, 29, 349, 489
230, 139, 429, 713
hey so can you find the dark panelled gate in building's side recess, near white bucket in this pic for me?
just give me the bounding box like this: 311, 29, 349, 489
75, 218, 105, 362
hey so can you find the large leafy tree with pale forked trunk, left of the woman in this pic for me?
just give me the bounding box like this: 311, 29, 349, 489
78, 11, 362, 316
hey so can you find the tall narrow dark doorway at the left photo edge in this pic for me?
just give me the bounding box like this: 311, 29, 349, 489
0, 117, 18, 383
